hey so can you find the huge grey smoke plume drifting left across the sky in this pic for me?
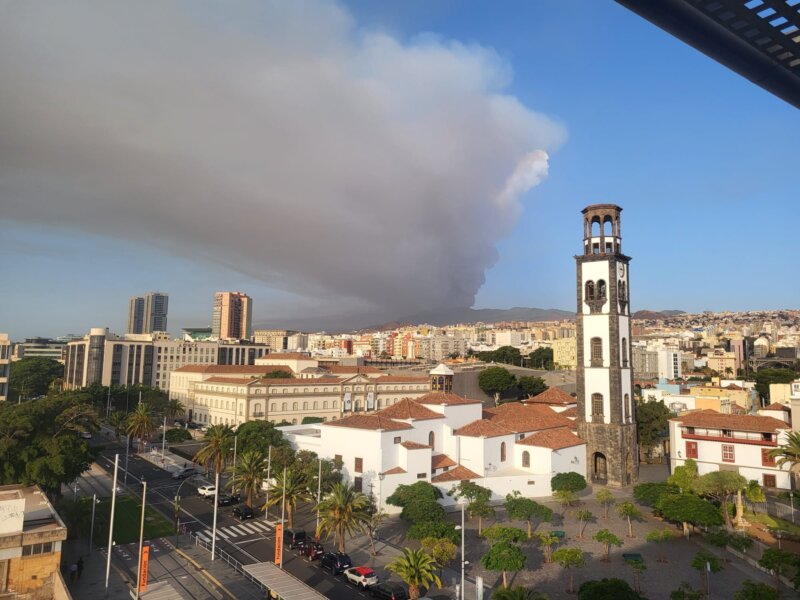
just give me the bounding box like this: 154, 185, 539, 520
0, 0, 566, 316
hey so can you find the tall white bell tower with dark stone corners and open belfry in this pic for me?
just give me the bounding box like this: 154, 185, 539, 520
575, 204, 639, 486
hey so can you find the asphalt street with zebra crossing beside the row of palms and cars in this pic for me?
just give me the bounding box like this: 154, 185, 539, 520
92, 438, 369, 600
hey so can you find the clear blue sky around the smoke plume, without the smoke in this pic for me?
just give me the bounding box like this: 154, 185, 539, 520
0, 0, 800, 339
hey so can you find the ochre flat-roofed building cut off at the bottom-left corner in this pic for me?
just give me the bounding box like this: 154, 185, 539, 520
0, 485, 70, 600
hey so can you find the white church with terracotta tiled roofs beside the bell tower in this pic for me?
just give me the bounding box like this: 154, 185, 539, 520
282, 394, 586, 513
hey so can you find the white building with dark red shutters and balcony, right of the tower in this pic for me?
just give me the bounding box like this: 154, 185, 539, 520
669, 410, 791, 489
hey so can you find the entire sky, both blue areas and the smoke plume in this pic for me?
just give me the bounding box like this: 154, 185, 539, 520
0, 0, 800, 339
